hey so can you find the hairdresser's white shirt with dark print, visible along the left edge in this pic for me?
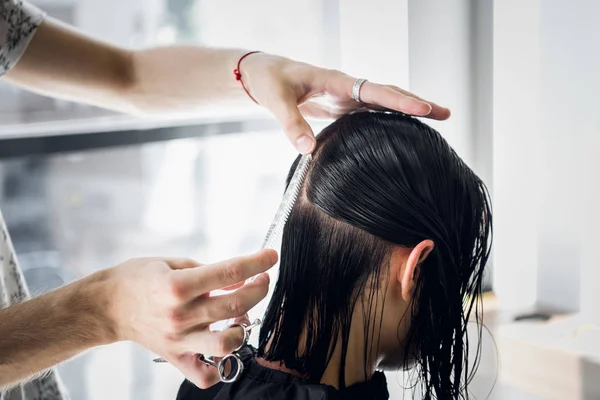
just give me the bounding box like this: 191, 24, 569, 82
0, 0, 68, 400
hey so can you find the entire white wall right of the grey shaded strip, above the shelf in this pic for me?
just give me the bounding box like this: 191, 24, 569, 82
494, 0, 600, 312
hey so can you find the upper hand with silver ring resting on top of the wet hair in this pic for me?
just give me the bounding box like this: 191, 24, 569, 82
240, 53, 450, 154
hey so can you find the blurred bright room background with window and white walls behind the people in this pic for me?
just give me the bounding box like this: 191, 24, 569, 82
0, 0, 600, 400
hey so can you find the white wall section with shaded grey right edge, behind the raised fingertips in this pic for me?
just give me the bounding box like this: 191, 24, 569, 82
408, 0, 493, 285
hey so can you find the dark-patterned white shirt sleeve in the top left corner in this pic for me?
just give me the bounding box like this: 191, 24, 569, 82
0, 0, 45, 77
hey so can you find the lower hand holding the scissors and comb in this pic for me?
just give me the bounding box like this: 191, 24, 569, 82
109, 250, 277, 388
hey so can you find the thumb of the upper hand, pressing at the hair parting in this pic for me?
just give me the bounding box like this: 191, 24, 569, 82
267, 94, 316, 154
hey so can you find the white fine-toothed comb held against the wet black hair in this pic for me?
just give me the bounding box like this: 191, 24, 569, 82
262, 154, 312, 249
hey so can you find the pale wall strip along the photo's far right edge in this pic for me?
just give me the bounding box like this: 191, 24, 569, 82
538, 0, 600, 320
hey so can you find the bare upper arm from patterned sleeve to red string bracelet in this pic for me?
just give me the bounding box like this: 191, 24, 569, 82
7, 18, 251, 113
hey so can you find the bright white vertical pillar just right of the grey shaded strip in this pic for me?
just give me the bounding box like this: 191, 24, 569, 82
493, 0, 543, 308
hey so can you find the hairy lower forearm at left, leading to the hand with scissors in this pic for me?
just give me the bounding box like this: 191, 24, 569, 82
0, 272, 117, 389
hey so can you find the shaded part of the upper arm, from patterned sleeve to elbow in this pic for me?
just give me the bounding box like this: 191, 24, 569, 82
6, 17, 133, 111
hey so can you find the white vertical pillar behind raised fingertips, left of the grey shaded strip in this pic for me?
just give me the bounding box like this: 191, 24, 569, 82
409, 0, 474, 165
